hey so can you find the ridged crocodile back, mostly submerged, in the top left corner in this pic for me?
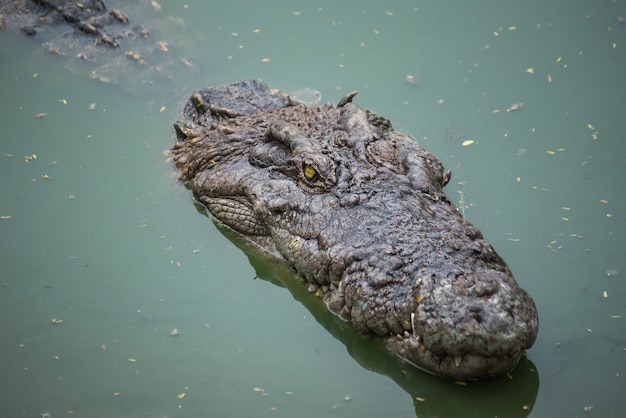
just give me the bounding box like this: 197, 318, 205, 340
0, 0, 195, 91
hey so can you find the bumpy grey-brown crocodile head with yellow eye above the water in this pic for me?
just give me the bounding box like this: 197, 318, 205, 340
172, 81, 538, 379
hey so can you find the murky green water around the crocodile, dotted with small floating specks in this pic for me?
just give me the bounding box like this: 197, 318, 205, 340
0, 0, 626, 417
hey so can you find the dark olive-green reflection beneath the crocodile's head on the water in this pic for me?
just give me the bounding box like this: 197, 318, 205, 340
207, 212, 539, 417
